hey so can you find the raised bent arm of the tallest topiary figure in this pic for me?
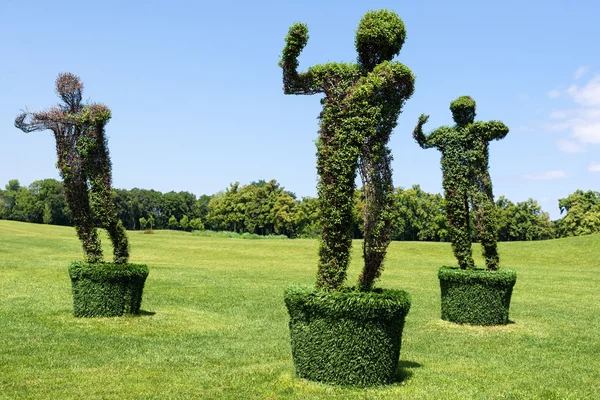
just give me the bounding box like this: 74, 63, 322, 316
279, 22, 323, 94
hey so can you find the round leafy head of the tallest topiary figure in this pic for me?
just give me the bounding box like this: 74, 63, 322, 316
354, 10, 406, 70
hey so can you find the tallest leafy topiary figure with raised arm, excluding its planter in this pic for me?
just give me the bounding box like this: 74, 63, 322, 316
279, 10, 414, 290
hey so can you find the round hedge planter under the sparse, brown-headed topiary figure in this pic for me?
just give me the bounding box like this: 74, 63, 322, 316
69, 261, 148, 317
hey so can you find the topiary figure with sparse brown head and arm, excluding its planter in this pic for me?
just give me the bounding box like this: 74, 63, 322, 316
15, 73, 129, 264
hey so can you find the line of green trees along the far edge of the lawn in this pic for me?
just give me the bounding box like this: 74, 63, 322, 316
0, 179, 600, 241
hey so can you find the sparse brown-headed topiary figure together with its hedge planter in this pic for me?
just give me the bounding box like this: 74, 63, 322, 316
15, 73, 148, 316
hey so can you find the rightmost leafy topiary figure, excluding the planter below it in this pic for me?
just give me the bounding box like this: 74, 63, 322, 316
413, 96, 508, 271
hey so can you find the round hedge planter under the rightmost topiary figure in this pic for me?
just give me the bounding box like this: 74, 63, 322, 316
438, 267, 517, 326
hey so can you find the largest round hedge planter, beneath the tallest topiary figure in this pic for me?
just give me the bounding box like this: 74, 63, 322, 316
284, 286, 410, 386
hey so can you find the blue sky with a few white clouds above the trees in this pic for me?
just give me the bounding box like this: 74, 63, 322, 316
0, 0, 600, 218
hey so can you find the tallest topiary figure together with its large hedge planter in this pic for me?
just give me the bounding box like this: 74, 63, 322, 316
279, 10, 414, 385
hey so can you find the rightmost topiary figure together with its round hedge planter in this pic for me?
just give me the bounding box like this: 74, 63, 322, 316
413, 96, 516, 325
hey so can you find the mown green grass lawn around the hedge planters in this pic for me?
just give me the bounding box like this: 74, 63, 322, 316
0, 221, 600, 400
